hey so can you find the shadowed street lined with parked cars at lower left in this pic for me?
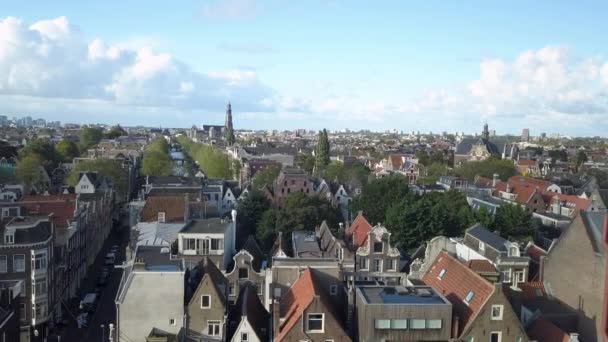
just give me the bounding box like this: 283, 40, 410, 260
60, 220, 129, 342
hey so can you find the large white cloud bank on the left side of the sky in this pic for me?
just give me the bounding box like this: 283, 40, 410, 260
0, 17, 272, 111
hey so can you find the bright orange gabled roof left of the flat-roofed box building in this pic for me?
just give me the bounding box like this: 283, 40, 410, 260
275, 268, 340, 341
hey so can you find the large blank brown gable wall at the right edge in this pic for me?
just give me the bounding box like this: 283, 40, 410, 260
541, 212, 606, 341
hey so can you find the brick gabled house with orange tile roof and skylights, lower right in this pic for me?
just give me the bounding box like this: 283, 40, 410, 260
422, 251, 528, 342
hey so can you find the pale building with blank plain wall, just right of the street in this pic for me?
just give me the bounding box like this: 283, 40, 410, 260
116, 246, 185, 342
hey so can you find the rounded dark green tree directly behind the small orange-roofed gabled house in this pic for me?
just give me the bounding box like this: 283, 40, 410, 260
351, 175, 408, 224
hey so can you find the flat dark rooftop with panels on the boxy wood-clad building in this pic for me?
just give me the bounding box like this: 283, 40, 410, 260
357, 286, 450, 305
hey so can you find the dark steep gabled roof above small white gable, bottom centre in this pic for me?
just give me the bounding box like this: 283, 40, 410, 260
226, 282, 270, 341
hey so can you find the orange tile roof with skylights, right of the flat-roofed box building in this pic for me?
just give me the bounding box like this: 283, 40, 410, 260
422, 251, 495, 334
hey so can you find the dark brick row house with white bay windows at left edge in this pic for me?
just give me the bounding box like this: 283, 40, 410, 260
0, 216, 53, 341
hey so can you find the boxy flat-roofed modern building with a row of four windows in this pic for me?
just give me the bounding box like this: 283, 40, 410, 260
356, 286, 452, 342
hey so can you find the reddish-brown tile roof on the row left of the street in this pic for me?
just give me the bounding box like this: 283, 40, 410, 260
19, 194, 76, 228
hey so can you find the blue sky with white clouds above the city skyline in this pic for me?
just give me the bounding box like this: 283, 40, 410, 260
0, 0, 608, 136
